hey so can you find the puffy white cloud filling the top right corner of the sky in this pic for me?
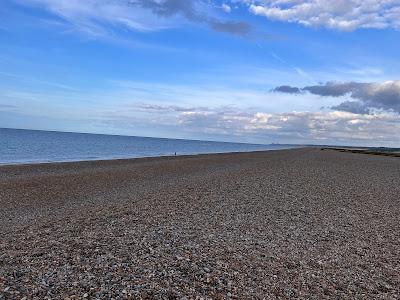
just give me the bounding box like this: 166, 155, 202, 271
239, 0, 400, 30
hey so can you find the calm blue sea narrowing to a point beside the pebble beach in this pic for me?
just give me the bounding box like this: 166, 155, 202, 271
0, 128, 293, 164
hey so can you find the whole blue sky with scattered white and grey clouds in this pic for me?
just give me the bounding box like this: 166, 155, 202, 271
0, 0, 400, 147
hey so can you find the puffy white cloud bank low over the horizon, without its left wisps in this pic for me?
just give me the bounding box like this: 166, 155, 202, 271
178, 111, 400, 144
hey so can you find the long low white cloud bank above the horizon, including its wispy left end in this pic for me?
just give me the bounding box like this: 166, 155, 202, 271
105, 105, 400, 146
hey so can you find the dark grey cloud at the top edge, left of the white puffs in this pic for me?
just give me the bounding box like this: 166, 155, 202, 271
131, 0, 251, 36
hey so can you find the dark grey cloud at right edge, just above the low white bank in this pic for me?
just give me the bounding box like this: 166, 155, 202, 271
273, 80, 400, 114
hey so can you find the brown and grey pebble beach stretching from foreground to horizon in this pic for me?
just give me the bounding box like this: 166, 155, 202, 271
0, 149, 400, 300
